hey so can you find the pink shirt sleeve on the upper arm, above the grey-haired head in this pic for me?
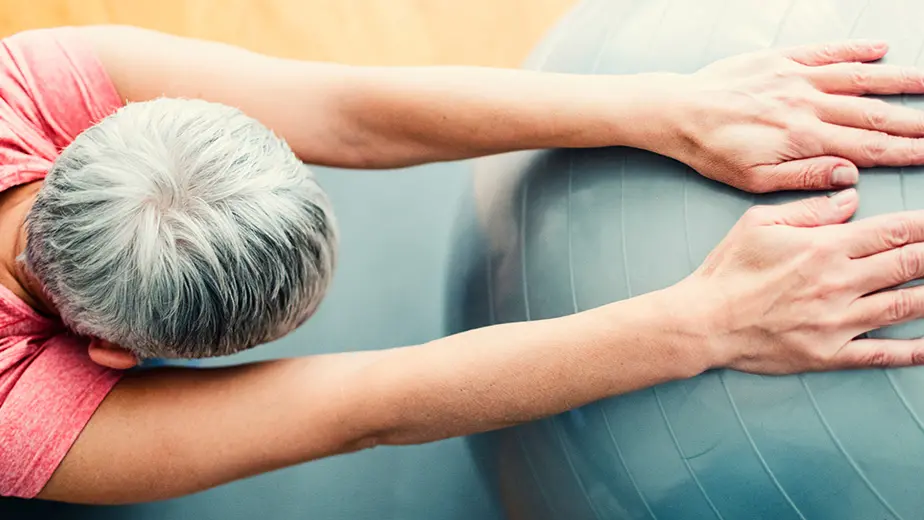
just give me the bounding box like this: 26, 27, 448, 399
0, 27, 123, 156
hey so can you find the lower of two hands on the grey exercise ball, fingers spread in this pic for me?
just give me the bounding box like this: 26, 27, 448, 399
684, 189, 924, 374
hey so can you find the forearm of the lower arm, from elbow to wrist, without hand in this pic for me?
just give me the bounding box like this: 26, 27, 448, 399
355, 293, 712, 444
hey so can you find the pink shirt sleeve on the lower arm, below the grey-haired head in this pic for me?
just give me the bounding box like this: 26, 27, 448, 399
0, 335, 121, 498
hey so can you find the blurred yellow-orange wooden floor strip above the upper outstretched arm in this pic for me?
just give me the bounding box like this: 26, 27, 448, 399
0, 0, 573, 66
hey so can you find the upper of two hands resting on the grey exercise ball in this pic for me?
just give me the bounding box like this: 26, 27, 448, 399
654, 41, 924, 193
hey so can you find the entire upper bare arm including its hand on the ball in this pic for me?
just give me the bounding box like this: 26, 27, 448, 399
79, 26, 924, 192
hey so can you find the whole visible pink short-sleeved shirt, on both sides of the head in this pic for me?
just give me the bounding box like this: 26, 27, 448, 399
0, 28, 122, 498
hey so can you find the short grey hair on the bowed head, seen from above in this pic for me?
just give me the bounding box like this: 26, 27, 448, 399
24, 98, 337, 358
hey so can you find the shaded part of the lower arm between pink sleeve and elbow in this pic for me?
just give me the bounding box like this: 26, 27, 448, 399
39, 352, 379, 504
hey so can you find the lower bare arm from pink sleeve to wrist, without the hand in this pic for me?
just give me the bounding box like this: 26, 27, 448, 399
41, 288, 709, 503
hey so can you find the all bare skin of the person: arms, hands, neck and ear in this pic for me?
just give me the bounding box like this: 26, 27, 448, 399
0, 27, 924, 503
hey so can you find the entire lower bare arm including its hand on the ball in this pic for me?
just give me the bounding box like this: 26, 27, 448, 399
40, 190, 924, 503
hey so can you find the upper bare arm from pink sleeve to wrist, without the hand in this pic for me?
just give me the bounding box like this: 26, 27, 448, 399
80, 26, 686, 168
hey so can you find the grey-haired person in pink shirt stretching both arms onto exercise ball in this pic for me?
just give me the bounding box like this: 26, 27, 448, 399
0, 27, 924, 503
